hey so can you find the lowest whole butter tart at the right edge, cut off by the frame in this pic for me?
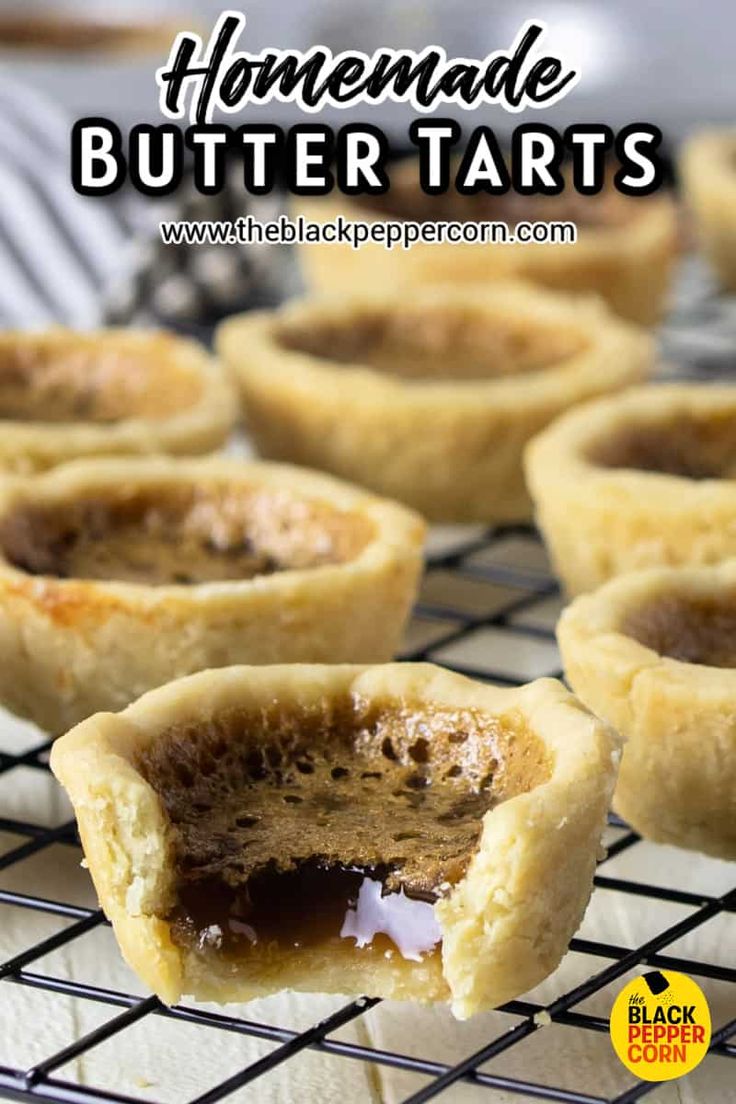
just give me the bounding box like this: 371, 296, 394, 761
558, 561, 736, 859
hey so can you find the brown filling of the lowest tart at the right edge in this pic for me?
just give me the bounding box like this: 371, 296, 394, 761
621, 594, 736, 668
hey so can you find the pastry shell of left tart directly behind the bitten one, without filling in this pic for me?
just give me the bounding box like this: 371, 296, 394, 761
0, 458, 425, 735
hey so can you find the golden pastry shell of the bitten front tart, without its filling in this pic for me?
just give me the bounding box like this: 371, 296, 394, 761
52, 664, 619, 1018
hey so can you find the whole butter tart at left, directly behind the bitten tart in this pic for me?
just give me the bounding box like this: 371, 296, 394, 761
0, 458, 425, 735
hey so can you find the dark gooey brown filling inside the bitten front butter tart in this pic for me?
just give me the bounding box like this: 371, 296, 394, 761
138, 696, 550, 957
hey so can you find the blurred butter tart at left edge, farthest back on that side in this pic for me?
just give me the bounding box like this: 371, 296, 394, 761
0, 329, 237, 473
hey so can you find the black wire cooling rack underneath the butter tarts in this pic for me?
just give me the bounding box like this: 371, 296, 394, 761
0, 260, 736, 1104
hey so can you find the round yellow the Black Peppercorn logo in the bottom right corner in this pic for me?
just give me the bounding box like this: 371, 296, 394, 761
610, 969, 711, 1081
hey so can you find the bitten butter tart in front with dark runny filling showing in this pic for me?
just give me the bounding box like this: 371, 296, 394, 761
52, 664, 619, 1018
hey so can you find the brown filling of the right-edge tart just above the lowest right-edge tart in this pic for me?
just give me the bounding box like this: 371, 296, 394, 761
588, 411, 736, 479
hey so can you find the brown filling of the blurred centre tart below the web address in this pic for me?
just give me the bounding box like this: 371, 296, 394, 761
277, 304, 586, 380
